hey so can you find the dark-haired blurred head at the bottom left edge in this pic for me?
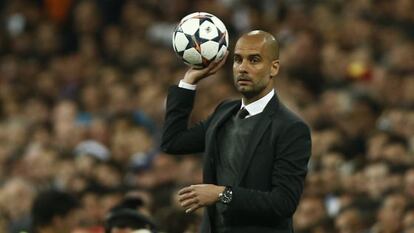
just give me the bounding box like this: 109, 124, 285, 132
32, 190, 81, 233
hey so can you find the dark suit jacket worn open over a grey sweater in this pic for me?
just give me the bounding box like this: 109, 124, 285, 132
161, 87, 311, 233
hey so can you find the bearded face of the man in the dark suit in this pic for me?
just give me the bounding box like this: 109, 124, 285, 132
233, 35, 279, 101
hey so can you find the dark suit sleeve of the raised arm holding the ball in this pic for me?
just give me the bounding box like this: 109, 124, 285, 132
161, 86, 208, 154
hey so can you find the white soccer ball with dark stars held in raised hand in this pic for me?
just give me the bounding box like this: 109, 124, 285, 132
172, 12, 229, 69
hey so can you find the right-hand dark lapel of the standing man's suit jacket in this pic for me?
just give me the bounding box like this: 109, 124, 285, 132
237, 94, 278, 185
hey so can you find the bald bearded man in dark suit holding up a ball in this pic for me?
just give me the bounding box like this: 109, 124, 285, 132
161, 31, 311, 233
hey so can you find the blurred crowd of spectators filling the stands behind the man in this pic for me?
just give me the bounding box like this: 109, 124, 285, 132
0, 0, 414, 233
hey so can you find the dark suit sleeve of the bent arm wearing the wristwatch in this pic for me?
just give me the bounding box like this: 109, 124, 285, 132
224, 122, 311, 220
